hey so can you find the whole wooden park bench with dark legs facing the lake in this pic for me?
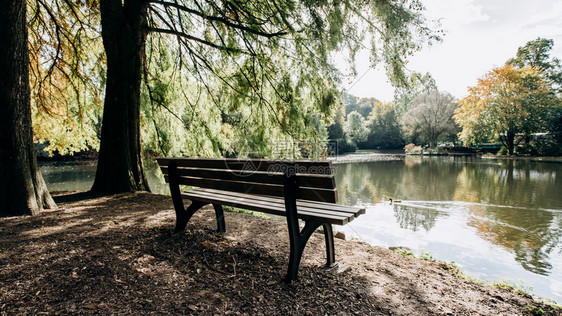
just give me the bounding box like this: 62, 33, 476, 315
157, 158, 365, 282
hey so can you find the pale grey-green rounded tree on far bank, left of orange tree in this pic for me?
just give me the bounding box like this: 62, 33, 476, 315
402, 91, 457, 148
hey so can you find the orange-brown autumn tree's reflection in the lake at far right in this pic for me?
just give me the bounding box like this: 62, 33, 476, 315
456, 160, 562, 275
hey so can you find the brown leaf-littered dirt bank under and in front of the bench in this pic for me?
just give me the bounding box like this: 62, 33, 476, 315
0, 193, 560, 315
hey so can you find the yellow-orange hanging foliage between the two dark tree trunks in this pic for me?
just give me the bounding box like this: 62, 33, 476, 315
28, 1, 105, 155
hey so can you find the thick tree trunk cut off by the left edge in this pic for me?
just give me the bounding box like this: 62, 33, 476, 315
0, 1, 56, 216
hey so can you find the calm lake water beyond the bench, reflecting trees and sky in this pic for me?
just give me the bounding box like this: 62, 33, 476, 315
41, 155, 562, 303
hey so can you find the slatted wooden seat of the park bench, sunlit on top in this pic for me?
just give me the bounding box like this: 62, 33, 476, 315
182, 190, 354, 225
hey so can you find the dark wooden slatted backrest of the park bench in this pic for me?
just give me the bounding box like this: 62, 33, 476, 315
156, 158, 337, 203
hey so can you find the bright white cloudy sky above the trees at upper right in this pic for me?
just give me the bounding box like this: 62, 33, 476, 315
344, 0, 562, 101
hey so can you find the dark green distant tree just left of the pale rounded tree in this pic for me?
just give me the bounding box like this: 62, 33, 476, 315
366, 102, 404, 149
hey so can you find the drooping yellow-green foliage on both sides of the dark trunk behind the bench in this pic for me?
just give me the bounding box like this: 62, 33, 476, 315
30, 0, 441, 157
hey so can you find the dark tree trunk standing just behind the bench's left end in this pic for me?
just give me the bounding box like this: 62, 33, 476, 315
92, 0, 149, 194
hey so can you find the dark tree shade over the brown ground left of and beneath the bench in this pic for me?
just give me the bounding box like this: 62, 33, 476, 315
0, 193, 384, 314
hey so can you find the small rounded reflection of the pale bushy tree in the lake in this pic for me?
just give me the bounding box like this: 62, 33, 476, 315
394, 204, 445, 232
